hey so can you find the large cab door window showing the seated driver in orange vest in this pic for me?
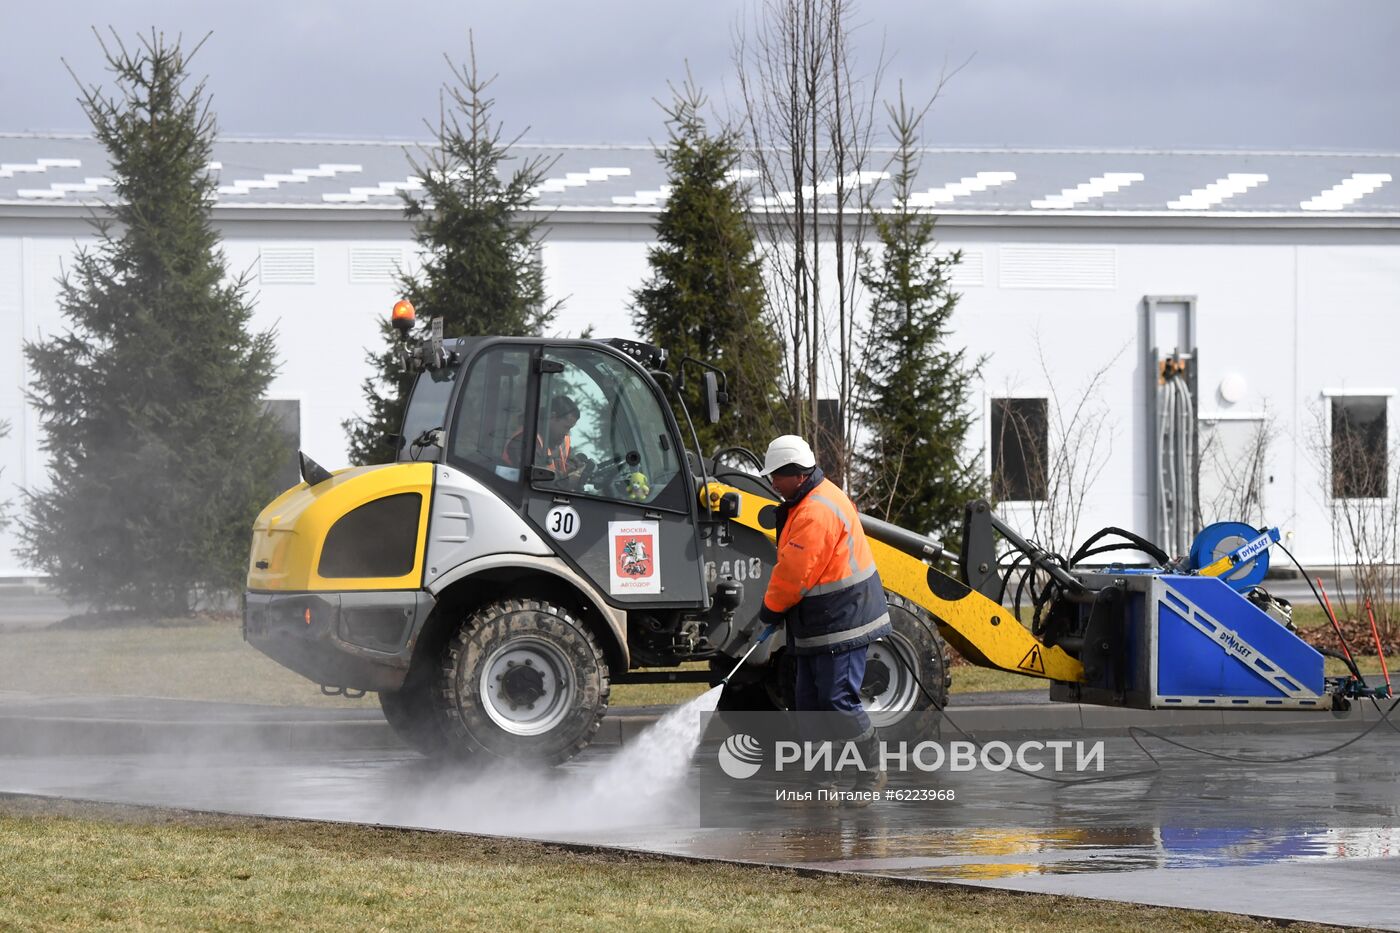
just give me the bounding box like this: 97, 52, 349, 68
531, 347, 686, 510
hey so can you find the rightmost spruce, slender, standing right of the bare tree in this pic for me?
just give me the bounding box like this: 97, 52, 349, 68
857, 91, 983, 535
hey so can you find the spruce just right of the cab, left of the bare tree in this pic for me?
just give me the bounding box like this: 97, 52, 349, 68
633, 78, 785, 454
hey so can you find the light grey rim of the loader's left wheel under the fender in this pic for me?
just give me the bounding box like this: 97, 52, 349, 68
480, 637, 578, 735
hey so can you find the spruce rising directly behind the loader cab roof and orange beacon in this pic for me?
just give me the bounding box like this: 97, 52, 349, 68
344, 43, 559, 464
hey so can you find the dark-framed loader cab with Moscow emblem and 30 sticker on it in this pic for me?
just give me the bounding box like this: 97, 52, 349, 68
399, 338, 708, 609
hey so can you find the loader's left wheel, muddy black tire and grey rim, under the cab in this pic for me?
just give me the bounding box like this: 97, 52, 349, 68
433, 600, 609, 765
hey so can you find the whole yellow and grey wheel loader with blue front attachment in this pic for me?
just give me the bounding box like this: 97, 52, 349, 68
244, 307, 1360, 762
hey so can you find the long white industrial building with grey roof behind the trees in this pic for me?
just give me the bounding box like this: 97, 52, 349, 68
0, 134, 1400, 577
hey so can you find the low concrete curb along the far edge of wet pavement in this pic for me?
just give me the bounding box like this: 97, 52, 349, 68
0, 689, 1377, 756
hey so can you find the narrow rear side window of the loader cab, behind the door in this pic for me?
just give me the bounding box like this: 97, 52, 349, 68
449, 346, 531, 483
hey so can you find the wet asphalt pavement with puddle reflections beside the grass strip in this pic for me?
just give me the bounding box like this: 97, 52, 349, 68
0, 714, 1400, 930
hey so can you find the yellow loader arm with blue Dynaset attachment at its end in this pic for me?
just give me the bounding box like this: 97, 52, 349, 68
708, 481, 1357, 709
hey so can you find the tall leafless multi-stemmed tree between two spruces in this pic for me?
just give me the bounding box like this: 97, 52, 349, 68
735, 0, 886, 478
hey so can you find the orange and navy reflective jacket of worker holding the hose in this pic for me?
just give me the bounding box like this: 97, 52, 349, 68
763, 471, 890, 654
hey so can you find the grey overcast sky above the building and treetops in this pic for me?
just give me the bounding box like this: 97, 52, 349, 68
0, 0, 1400, 151
